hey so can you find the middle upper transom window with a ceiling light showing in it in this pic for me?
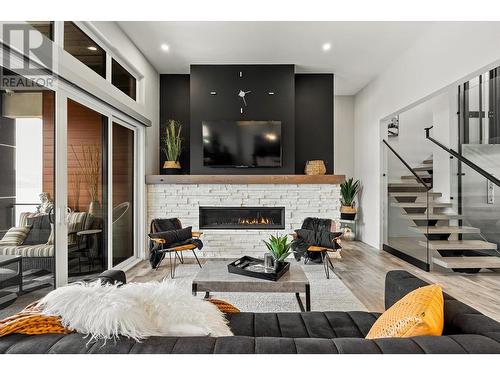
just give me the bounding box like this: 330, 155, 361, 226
64, 21, 106, 78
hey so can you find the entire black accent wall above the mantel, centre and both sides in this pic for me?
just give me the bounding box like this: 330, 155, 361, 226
160, 65, 334, 175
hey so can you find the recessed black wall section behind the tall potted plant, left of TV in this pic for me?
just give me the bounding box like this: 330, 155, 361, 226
160, 74, 190, 174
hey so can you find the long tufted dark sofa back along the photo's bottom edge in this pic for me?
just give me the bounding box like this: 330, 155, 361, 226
0, 333, 500, 354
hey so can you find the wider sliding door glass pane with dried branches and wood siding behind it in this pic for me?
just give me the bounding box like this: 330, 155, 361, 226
67, 99, 108, 278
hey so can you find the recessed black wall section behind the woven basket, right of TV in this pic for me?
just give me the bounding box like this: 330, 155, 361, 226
295, 74, 334, 174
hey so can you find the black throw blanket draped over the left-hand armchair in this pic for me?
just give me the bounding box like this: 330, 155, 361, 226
149, 218, 203, 268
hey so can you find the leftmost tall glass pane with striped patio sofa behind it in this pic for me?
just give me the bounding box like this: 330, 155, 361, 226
0, 69, 55, 296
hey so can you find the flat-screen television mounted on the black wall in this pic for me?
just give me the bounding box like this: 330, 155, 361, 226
202, 121, 281, 168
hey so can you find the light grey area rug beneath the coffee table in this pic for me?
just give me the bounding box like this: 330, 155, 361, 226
164, 263, 367, 312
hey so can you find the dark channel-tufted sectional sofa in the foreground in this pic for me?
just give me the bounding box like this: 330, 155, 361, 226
0, 271, 500, 354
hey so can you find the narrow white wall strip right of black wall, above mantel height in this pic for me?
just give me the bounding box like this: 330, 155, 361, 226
333, 95, 354, 176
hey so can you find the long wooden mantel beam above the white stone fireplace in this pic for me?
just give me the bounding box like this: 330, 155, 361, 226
146, 174, 345, 185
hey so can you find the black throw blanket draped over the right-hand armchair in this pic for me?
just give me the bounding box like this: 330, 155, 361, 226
292, 217, 342, 263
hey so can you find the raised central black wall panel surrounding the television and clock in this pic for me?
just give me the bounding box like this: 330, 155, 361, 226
191, 65, 295, 174
